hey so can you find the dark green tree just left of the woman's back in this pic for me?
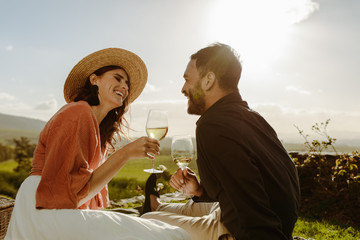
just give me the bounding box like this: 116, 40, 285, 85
13, 137, 35, 173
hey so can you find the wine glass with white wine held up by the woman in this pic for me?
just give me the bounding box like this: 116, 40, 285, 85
144, 110, 168, 173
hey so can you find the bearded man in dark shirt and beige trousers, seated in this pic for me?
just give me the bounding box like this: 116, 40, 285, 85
144, 44, 300, 240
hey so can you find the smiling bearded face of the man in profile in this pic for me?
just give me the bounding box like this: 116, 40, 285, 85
181, 60, 205, 115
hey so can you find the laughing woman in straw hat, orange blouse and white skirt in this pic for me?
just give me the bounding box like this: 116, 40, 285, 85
5, 48, 189, 239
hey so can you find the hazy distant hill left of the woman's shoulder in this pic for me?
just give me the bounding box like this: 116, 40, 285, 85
0, 113, 46, 144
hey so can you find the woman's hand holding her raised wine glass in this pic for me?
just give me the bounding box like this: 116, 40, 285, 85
123, 137, 160, 159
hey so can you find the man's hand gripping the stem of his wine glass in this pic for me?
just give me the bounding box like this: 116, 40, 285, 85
170, 168, 203, 197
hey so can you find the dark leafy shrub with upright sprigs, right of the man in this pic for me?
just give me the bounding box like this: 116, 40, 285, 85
290, 120, 360, 227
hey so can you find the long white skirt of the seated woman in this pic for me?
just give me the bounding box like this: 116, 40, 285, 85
5, 176, 190, 240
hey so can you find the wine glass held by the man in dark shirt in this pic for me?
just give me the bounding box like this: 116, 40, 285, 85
171, 135, 194, 194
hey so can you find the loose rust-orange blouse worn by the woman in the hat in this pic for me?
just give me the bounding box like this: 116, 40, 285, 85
31, 101, 109, 209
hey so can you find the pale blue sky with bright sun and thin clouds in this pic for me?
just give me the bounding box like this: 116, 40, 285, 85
0, 0, 360, 144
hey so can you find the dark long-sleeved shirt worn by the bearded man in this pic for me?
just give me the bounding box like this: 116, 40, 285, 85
193, 92, 300, 240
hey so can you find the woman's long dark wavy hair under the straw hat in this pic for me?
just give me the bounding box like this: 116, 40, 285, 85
74, 63, 130, 150
